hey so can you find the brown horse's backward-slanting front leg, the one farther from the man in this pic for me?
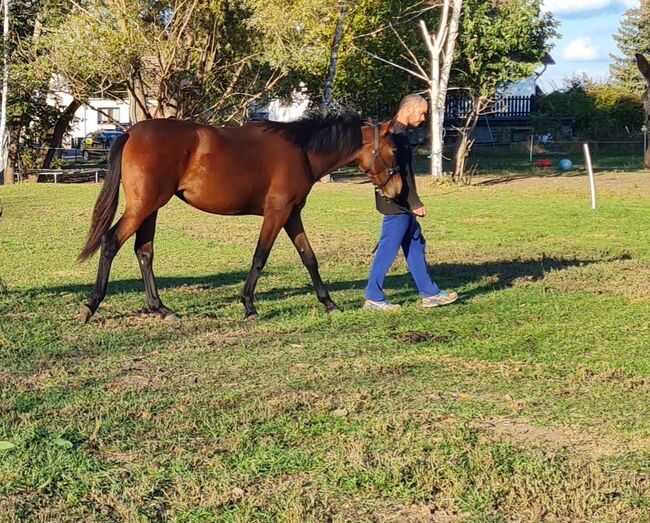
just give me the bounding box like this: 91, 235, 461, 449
241, 206, 292, 321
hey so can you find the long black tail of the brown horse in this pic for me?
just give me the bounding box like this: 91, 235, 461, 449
77, 133, 129, 262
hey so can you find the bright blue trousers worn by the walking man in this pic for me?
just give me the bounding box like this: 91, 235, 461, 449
366, 214, 440, 301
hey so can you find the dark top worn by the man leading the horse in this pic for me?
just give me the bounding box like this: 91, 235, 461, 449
375, 122, 424, 214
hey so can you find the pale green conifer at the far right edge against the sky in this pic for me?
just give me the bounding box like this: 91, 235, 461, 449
609, 0, 650, 94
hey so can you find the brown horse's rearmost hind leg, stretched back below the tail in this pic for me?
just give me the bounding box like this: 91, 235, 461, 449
80, 212, 140, 323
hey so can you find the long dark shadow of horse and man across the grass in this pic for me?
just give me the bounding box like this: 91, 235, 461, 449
16, 255, 630, 318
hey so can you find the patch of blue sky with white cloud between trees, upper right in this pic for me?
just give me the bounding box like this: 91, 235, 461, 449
538, 0, 639, 92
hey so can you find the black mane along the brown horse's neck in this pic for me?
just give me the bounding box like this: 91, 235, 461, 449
264, 114, 365, 154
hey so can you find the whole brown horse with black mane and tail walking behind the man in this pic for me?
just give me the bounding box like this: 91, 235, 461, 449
79, 112, 402, 322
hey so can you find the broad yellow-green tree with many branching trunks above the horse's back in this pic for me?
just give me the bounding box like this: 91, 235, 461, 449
47, 0, 316, 122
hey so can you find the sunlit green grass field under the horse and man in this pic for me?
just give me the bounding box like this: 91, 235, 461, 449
0, 172, 650, 522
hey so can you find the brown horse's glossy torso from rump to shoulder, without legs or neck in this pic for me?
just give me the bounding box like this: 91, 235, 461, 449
123, 120, 311, 214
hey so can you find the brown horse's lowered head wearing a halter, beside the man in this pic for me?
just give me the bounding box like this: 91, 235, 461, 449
357, 120, 402, 199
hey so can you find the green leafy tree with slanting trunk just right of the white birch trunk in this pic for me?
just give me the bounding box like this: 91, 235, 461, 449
452, 0, 557, 181
